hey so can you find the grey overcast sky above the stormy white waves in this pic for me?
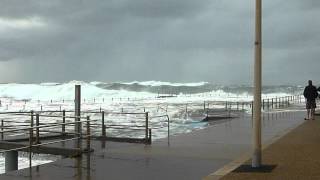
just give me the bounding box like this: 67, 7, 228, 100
0, 0, 320, 84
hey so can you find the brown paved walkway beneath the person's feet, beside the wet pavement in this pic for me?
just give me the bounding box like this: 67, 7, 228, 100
211, 112, 320, 180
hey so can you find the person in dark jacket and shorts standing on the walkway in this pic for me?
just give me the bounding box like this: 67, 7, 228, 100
303, 80, 319, 120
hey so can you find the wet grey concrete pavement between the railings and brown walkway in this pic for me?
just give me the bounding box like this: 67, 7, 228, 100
0, 109, 304, 180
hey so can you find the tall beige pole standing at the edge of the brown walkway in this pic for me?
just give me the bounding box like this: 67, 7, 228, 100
252, 0, 262, 168
